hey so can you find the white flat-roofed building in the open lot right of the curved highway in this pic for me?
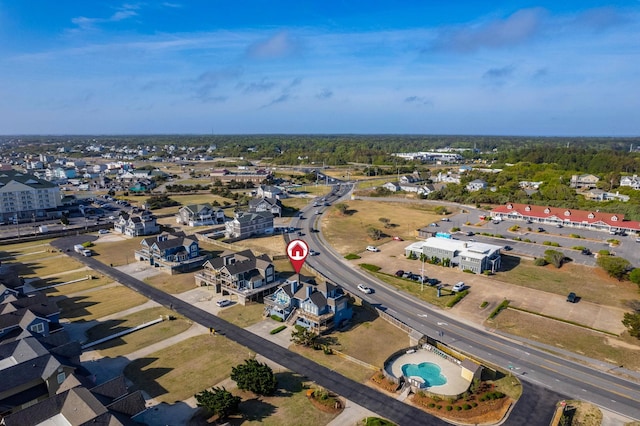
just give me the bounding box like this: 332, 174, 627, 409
405, 237, 502, 274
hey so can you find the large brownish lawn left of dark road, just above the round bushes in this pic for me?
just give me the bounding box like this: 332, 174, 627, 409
124, 335, 250, 403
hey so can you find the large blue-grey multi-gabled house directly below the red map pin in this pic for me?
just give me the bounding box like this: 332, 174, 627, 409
264, 280, 353, 333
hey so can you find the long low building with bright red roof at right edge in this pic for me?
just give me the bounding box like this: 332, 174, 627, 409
491, 203, 640, 232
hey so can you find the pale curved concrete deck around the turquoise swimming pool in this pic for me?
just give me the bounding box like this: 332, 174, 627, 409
387, 349, 470, 395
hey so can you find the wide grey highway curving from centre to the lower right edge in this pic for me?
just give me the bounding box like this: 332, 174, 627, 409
298, 184, 640, 419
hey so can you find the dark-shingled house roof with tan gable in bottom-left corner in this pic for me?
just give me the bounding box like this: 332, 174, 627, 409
1, 373, 146, 426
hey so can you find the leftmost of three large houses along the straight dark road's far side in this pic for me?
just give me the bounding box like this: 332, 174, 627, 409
134, 232, 209, 274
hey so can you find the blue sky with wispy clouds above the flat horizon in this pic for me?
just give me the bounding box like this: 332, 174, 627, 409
0, 0, 640, 136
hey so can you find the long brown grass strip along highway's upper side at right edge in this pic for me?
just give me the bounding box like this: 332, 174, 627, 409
487, 309, 640, 370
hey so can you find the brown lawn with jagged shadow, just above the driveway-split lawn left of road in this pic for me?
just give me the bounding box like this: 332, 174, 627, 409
58, 286, 147, 321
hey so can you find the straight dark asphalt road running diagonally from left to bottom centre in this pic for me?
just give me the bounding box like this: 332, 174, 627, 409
51, 235, 448, 426
